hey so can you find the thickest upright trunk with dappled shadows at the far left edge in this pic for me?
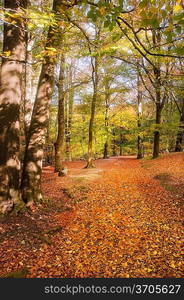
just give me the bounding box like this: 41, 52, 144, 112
0, 0, 27, 213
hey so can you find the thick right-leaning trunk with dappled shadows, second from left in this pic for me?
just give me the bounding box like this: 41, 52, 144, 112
21, 0, 59, 203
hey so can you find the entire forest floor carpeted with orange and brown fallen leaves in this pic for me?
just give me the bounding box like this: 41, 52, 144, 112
0, 153, 184, 278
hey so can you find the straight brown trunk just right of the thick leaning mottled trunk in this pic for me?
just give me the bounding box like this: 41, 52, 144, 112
55, 55, 65, 176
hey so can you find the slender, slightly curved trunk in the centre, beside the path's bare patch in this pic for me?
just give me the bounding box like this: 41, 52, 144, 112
86, 57, 98, 168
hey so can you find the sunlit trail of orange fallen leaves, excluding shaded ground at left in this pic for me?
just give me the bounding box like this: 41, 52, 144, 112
0, 157, 183, 277
